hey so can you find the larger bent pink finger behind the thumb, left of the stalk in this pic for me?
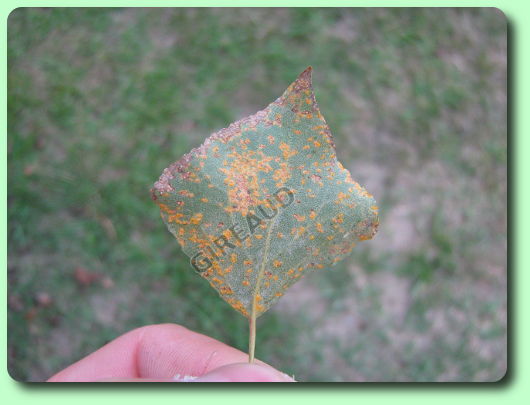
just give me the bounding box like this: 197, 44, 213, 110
49, 324, 270, 382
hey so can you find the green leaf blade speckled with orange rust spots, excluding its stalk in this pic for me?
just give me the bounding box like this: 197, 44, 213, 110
152, 67, 378, 324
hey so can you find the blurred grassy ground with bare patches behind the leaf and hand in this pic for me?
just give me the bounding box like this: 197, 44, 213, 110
7, 8, 507, 381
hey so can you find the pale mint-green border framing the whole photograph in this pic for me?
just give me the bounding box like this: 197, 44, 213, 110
0, 0, 530, 405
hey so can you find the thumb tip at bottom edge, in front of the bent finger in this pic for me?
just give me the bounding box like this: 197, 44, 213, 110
187, 363, 295, 382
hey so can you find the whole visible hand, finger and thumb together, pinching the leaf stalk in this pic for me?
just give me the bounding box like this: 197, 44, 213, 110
48, 324, 294, 382
